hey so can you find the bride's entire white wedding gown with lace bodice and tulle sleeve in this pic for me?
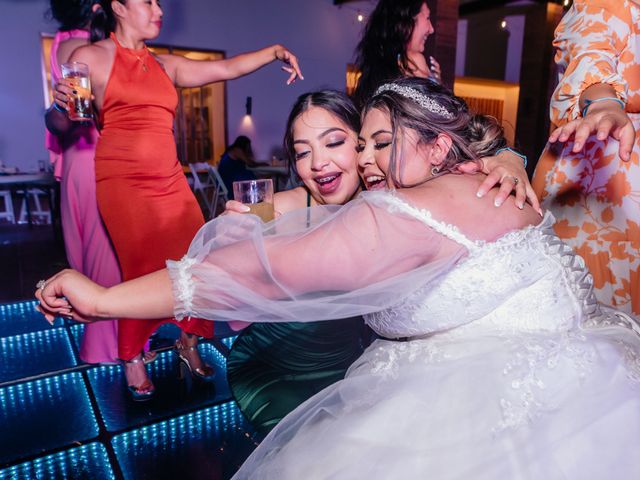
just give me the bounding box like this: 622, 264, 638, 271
169, 193, 640, 480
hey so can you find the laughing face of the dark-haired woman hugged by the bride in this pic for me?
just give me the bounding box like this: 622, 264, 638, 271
292, 107, 360, 205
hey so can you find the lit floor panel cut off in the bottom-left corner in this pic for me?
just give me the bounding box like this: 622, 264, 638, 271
0, 443, 116, 480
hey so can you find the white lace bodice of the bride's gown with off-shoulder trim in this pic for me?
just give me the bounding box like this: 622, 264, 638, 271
365, 196, 606, 338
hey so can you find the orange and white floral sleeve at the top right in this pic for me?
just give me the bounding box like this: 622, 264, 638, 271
550, 0, 632, 125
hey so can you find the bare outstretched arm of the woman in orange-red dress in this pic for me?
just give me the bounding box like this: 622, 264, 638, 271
159, 45, 304, 87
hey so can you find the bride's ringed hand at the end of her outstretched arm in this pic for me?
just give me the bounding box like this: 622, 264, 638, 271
35, 269, 106, 324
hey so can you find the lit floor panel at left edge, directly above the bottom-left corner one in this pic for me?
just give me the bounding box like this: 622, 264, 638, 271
0, 373, 98, 464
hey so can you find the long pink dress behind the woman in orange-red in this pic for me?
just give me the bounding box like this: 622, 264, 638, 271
46, 30, 121, 363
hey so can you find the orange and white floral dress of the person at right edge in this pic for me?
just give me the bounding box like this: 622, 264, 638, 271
533, 0, 640, 315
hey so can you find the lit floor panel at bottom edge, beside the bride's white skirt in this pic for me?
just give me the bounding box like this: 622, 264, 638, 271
112, 403, 256, 480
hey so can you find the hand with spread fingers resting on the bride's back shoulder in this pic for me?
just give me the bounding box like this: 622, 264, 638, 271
458, 150, 543, 216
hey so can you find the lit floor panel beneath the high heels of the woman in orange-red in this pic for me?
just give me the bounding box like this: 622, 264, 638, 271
87, 344, 231, 431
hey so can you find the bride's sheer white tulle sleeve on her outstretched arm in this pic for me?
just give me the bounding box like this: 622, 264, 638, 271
167, 192, 466, 322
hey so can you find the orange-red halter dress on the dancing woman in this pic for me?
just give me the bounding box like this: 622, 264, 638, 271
95, 34, 213, 360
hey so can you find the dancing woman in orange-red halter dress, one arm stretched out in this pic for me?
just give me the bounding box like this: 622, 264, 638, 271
56, 0, 301, 400
